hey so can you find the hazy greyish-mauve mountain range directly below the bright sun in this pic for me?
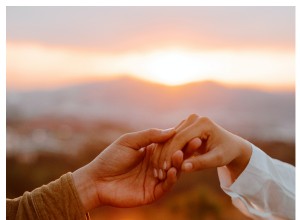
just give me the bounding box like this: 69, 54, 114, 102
6, 77, 295, 140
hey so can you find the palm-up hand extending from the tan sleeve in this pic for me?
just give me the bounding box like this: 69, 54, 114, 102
73, 129, 178, 211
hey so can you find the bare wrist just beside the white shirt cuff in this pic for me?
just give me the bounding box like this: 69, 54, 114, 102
226, 137, 252, 182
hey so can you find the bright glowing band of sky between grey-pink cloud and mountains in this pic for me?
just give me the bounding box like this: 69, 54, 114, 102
6, 42, 295, 88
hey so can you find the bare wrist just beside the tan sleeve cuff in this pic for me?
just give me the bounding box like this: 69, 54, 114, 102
72, 165, 100, 212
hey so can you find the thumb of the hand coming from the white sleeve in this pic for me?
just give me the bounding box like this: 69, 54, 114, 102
181, 148, 223, 172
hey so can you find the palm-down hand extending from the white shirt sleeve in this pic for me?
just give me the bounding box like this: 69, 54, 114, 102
153, 114, 252, 181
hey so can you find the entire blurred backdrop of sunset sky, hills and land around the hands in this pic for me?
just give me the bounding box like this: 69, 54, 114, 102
6, 7, 295, 220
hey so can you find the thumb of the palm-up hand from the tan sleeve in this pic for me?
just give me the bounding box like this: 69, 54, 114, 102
119, 128, 175, 150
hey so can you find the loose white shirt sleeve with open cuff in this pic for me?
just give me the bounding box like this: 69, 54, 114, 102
218, 145, 295, 219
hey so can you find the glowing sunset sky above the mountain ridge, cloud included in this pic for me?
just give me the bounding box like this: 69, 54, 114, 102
6, 6, 295, 89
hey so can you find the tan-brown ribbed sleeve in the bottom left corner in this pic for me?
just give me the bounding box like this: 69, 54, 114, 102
6, 173, 89, 220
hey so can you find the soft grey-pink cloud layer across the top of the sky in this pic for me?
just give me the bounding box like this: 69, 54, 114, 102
7, 6, 295, 53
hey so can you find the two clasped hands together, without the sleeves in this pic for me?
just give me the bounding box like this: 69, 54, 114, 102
73, 114, 252, 211
